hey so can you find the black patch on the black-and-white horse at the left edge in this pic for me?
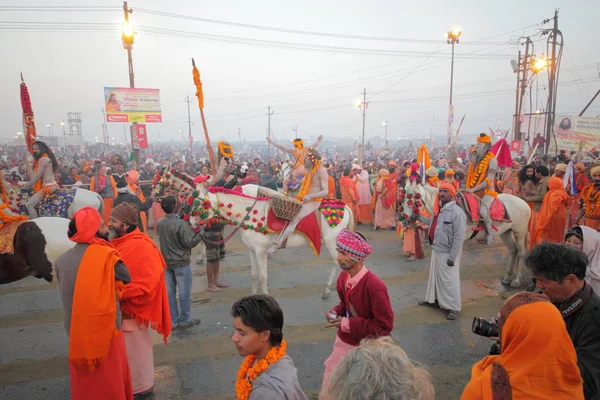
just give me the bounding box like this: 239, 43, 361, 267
13, 221, 52, 282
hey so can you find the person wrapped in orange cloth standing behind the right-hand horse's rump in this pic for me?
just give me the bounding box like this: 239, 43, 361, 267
531, 176, 569, 246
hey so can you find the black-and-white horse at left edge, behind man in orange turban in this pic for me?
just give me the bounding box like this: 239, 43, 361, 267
0, 217, 75, 284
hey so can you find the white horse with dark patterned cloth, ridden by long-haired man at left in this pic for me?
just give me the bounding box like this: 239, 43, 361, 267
0, 175, 104, 218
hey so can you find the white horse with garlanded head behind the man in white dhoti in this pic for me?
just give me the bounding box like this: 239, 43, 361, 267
399, 182, 531, 288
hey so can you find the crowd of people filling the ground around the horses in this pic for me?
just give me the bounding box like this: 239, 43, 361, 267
7, 134, 600, 400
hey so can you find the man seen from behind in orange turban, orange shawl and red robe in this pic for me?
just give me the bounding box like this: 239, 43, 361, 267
54, 207, 133, 400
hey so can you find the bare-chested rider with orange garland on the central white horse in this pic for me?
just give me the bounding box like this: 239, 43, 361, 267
267, 148, 329, 254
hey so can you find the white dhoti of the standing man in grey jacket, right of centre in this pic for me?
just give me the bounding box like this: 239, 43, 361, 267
425, 250, 462, 312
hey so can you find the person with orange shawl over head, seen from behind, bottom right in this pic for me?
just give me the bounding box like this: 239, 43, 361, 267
461, 292, 584, 400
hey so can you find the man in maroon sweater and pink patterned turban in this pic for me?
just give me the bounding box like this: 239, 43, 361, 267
322, 229, 394, 388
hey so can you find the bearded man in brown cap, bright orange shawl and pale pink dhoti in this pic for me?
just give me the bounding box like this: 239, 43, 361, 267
108, 203, 171, 394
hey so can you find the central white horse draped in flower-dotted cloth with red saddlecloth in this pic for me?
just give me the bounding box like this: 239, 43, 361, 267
184, 185, 354, 299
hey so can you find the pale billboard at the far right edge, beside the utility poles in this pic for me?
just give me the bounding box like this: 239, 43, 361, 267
550, 115, 600, 151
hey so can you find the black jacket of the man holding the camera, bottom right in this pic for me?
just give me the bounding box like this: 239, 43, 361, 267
558, 283, 600, 400
